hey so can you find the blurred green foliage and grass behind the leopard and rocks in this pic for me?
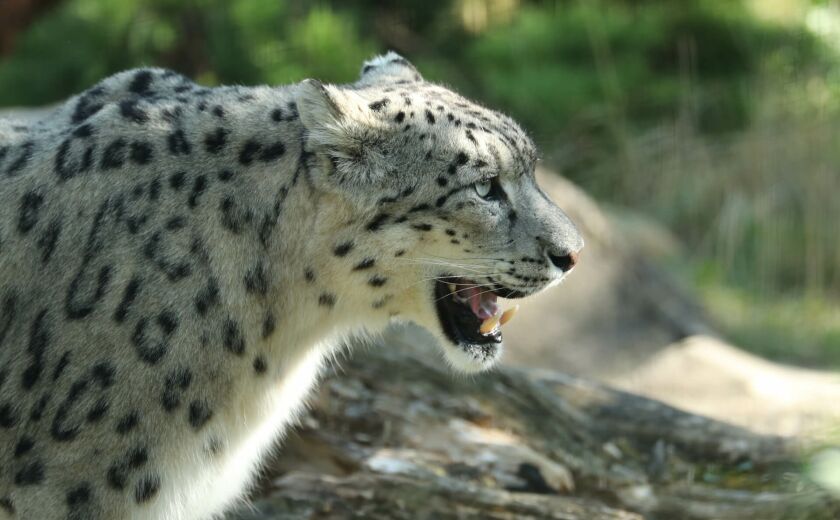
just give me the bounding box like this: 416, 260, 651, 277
0, 0, 840, 366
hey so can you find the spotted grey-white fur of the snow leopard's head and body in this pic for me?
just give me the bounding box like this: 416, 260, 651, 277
0, 53, 582, 520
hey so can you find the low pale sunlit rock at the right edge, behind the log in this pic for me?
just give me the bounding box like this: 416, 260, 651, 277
610, 336, 840, 435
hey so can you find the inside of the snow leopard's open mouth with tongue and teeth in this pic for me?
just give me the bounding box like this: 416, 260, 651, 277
435, 276, 519, 347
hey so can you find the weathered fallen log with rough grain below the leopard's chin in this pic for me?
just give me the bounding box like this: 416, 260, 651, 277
230, 333, 840, 520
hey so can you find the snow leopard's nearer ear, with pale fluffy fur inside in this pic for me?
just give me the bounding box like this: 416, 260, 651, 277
297, 79, 392, 186
